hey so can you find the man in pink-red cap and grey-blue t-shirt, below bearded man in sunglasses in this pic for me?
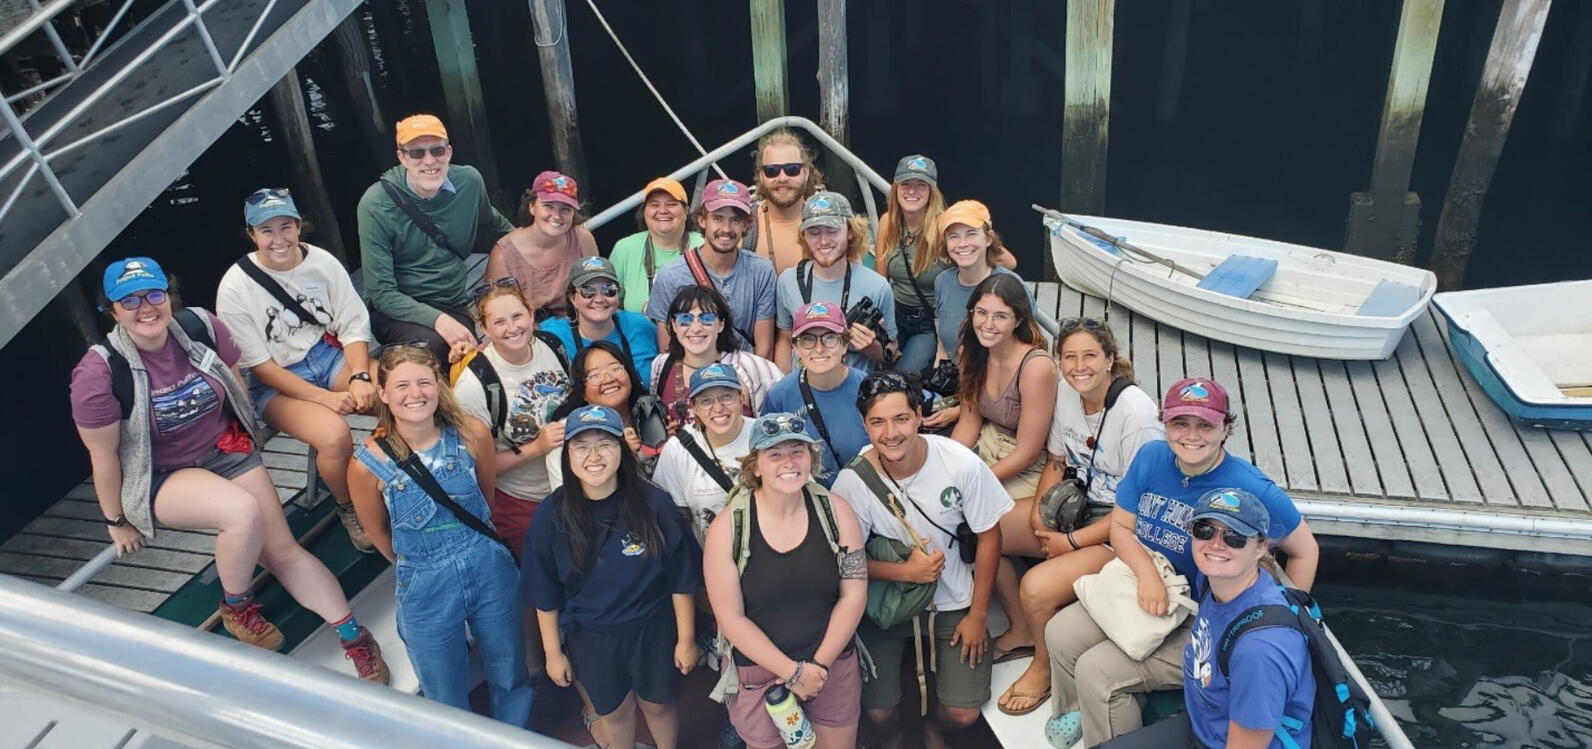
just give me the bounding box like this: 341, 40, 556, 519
646, 180, 775, 359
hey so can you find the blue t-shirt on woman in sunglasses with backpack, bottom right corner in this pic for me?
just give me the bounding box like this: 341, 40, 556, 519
1183, 569, 1315, 749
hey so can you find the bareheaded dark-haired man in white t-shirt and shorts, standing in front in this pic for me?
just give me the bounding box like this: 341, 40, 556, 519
833, 371, 1013, 747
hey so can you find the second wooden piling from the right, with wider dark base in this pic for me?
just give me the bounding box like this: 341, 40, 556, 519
1344, 0, 1444, 263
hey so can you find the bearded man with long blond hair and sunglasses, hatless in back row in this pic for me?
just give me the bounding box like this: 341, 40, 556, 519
753, 127, 823, 274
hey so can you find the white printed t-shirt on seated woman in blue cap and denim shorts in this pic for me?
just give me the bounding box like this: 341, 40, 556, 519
215, 244, 371, 370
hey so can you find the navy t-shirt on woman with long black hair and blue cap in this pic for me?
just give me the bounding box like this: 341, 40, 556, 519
519, 483, 702, 629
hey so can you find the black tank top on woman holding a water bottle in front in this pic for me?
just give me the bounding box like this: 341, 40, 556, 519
736, 499, 841, 662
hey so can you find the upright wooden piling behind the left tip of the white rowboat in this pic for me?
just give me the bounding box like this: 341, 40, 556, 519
1062, 0, 1116, 214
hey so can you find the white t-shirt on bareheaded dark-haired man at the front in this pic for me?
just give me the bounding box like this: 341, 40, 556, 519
829, 435, 1013, 610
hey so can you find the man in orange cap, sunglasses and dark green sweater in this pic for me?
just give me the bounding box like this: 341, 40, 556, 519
357, 115, 514, 362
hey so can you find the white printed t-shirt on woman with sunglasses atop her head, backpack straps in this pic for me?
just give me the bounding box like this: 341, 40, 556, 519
454, 338, 570, 502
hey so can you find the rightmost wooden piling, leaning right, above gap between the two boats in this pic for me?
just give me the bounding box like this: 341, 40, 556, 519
1430, 0, 1552, 288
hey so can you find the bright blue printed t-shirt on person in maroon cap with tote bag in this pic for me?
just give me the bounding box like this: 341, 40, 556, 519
1116, 440, 1299, 580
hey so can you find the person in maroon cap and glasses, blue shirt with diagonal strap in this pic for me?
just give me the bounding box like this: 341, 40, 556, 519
763, 301, 868, 486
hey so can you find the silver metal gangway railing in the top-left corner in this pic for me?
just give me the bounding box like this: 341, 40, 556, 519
0, 0, 277, 220
